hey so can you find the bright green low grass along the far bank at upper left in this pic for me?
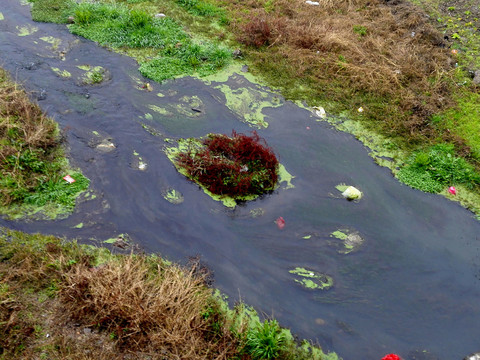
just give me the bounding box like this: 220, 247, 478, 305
32, 0, 231, 82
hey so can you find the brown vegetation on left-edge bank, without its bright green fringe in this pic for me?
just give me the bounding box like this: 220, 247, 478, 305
0, 69, 60, 205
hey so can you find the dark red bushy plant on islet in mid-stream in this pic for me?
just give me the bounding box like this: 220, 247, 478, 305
176, 131, 279, 198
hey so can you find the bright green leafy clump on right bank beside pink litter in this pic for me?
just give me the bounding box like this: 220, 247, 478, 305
397, 144, 480, 193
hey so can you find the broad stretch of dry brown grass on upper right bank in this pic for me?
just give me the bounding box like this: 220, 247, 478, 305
223, 0, 452, 139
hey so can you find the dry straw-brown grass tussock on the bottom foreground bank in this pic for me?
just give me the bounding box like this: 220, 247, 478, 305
60, 255, 240, 360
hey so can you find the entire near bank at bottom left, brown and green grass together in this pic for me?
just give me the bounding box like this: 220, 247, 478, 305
0, 229, 338, 360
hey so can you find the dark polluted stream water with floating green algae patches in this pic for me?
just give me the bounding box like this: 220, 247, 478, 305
0, 0, 480, 360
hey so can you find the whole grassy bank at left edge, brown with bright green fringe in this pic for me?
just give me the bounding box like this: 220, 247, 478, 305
0, 70, 89, 216
